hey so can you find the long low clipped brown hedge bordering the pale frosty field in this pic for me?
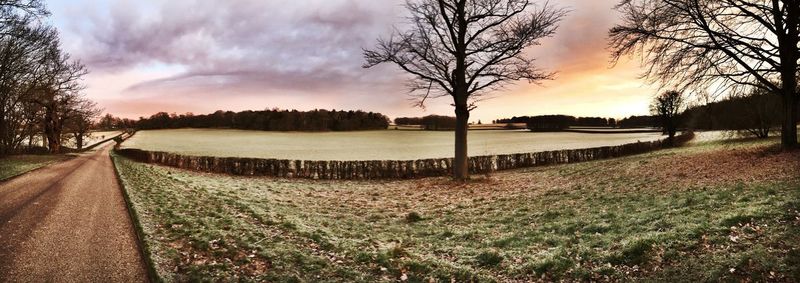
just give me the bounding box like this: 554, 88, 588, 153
117, 133, 694, 180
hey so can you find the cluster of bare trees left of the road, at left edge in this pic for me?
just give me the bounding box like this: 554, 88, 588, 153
0, 0, 100, 155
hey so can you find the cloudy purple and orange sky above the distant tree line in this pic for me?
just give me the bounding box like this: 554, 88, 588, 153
47, 0, 657, 122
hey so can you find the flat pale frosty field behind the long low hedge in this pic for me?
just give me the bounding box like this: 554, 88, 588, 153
123, 129, 662, 160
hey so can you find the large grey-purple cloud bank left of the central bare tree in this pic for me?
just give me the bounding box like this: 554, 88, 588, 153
64, 0, 401, 95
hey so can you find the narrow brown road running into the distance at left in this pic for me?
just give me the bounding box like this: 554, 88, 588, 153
0, 143, 147, 283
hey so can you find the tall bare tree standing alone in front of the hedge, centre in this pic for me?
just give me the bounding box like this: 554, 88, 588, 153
364, 0, 566, 180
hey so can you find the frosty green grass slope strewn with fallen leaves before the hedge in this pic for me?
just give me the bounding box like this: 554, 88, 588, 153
115, 140, 800, 282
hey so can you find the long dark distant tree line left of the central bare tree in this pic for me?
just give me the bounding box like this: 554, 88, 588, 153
136, 109, 389, 131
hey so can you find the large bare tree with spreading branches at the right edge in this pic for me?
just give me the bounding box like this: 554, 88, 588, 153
610, 0, 800, 149
